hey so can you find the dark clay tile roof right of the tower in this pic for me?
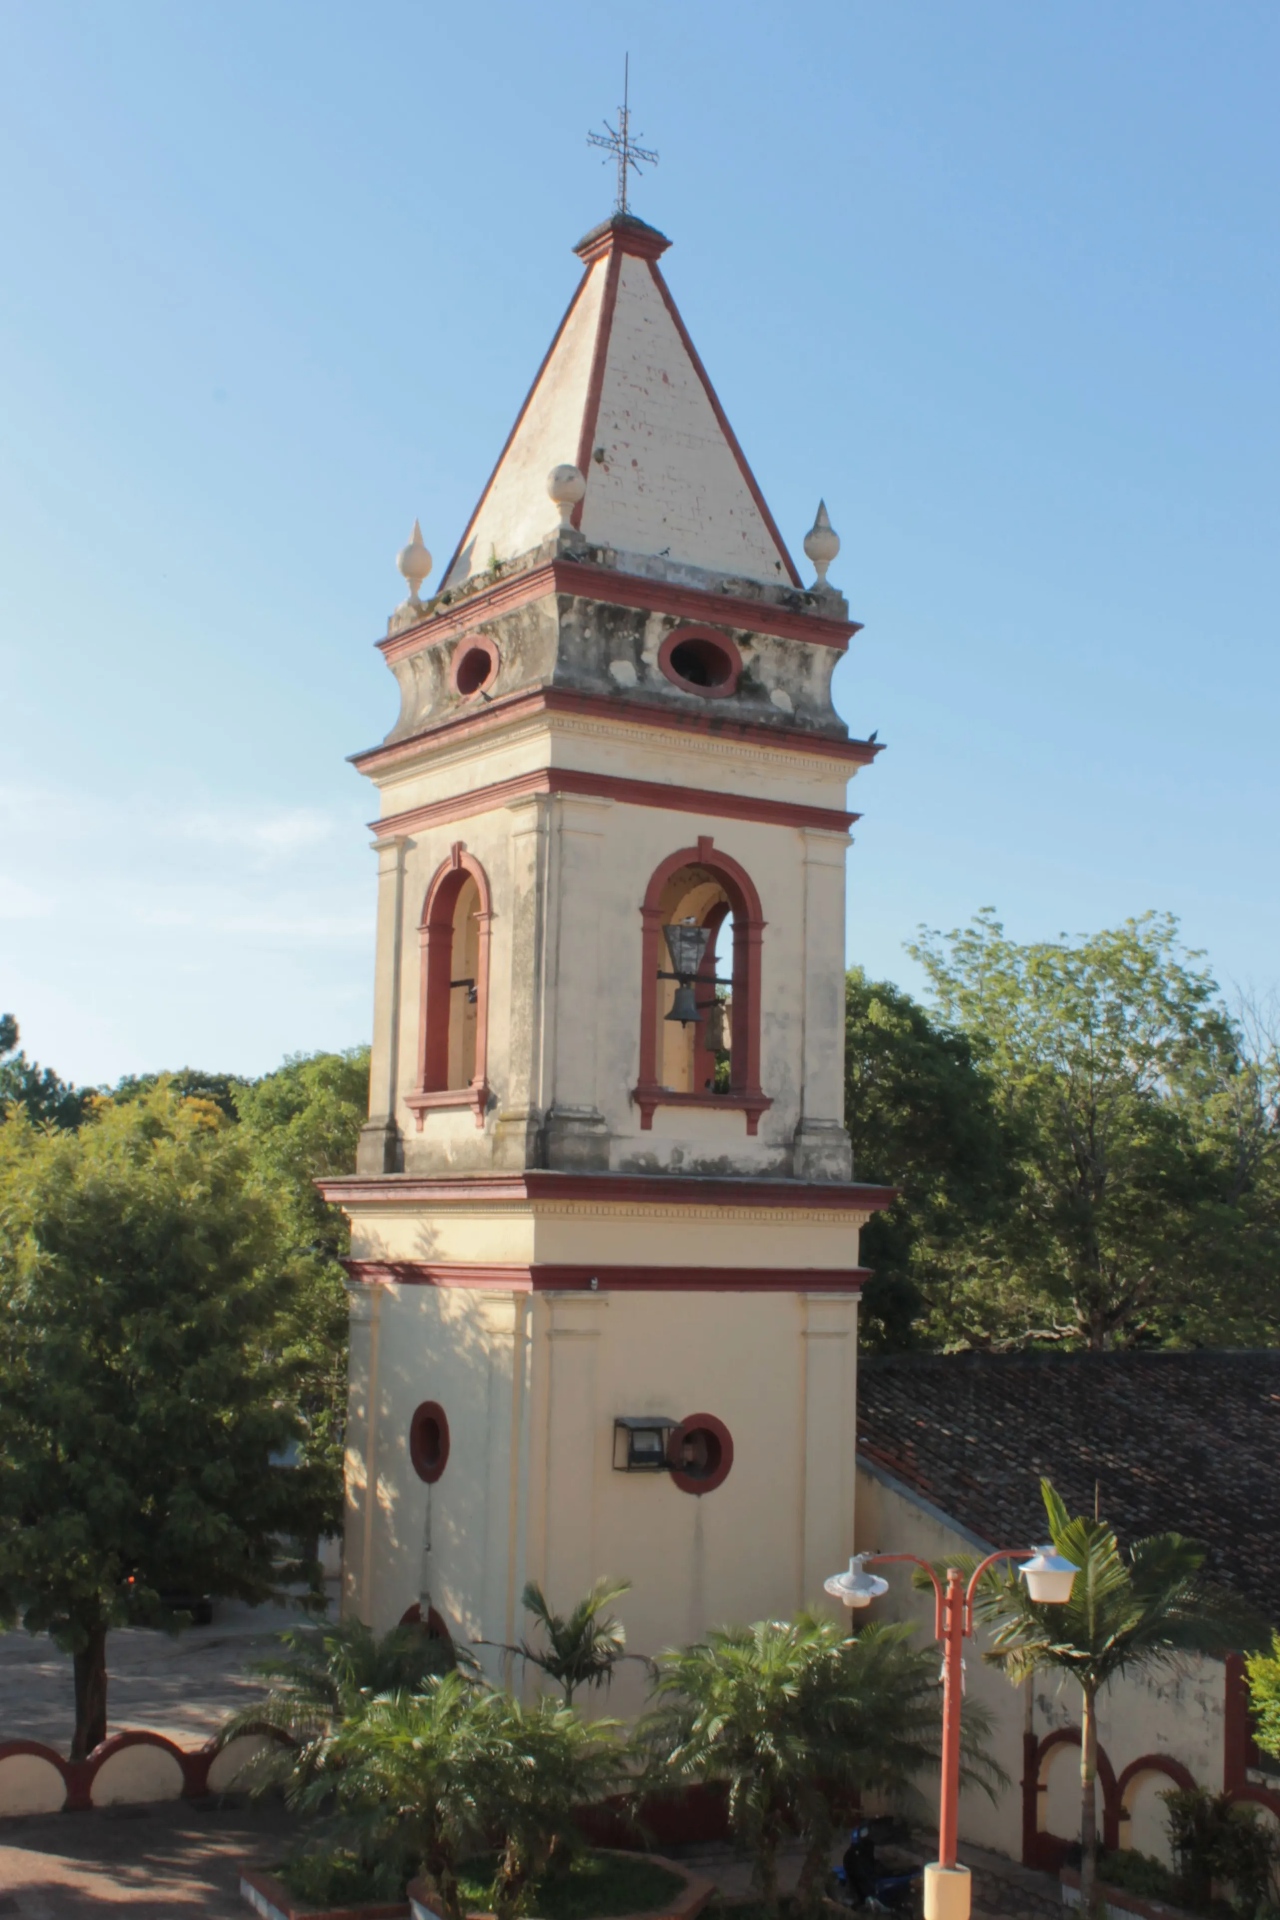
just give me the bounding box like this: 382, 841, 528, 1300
858, 1350, 1280, 1622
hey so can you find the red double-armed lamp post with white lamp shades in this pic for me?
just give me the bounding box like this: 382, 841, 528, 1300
823, 1546, 1080, 1920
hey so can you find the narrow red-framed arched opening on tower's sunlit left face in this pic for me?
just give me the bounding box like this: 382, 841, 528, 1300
405, 841, 493, 1133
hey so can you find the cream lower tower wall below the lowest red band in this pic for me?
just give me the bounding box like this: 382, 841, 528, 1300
347, 1286, 858, 1715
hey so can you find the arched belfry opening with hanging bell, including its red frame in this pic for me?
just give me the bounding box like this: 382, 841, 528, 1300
631, 835, 773, 1133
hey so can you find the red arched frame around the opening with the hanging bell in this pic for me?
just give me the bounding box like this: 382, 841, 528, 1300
631, 833, 773, 1133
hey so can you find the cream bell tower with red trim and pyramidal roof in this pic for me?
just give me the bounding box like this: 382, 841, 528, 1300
324, 213, 892, 1707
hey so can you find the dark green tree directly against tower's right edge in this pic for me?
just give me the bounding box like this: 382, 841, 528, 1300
844, 968, 1017, 1350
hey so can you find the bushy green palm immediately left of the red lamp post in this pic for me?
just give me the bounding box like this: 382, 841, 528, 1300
637, 1613, 1002, 1914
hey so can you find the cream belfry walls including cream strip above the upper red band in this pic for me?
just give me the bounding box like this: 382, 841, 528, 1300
360, 718, 848, 1171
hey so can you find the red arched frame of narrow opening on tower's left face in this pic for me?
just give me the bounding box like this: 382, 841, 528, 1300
405, 841, 493, 1133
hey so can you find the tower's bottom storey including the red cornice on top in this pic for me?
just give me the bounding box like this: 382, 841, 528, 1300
326, 1173, 889, 1713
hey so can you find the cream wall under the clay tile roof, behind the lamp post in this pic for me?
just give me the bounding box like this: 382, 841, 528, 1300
858, 1467, 1224, 1860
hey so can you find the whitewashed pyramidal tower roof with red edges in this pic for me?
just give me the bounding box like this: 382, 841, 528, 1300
443, 213, 800, 588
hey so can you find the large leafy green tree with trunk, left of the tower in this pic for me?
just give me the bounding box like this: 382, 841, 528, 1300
0, 1087, 340, 1759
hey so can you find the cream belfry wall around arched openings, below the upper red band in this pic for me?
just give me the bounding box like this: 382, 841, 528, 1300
380, 779, 846, 1171
